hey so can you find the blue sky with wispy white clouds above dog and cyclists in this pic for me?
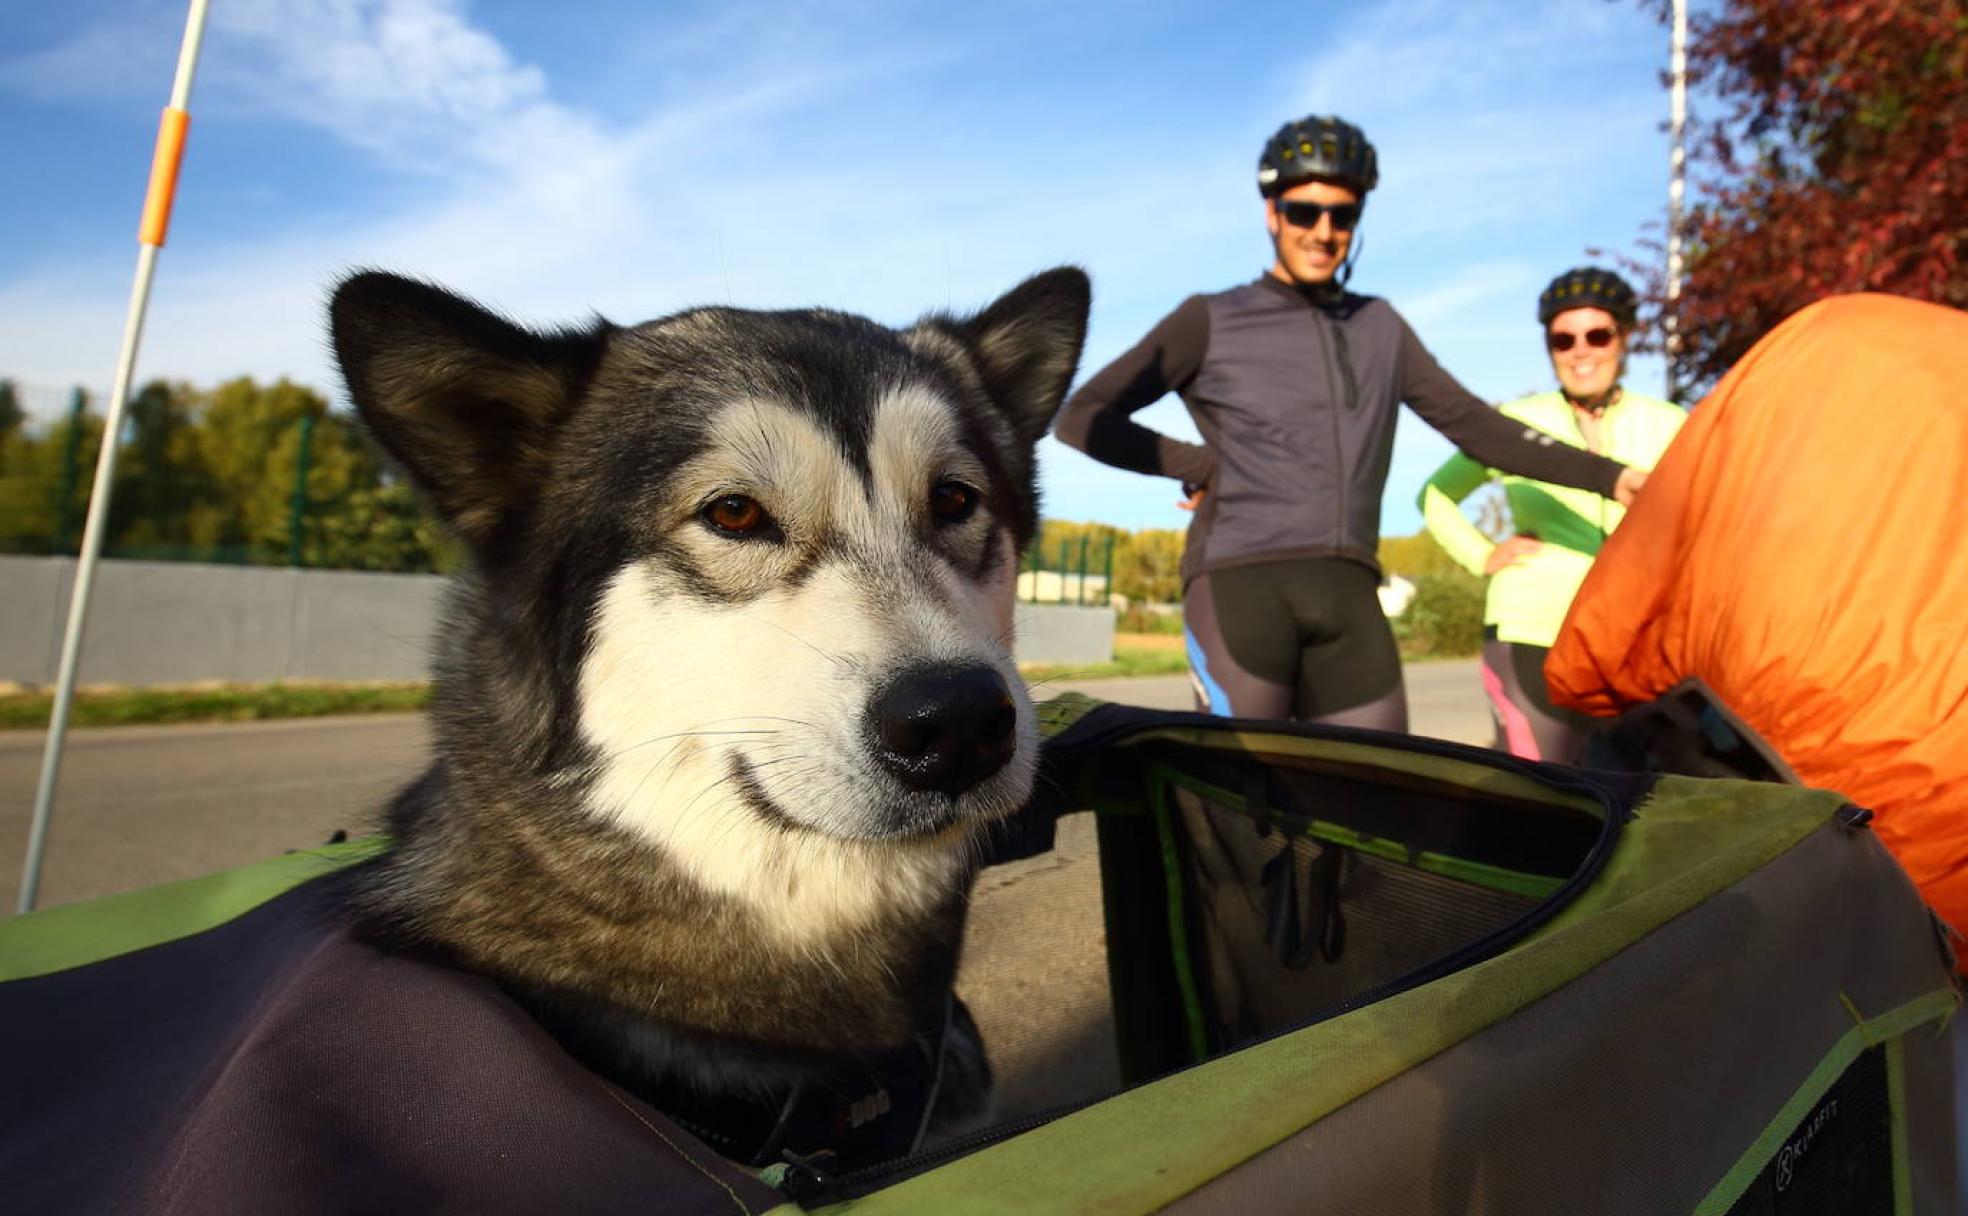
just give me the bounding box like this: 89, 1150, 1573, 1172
0, 0, 1667, 533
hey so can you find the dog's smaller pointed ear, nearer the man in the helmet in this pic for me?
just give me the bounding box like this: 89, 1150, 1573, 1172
956, 266, 1092, 445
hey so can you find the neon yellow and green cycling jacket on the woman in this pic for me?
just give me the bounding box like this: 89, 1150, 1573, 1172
1421, 390, 1687, 647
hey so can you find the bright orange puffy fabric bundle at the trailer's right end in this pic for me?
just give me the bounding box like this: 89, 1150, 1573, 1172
1545, 295, 1968, 936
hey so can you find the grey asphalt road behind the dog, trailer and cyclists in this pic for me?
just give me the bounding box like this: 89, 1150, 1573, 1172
0, 661, 1490, 1120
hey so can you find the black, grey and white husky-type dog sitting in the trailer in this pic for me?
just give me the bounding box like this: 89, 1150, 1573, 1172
331, 268, 1088, 1161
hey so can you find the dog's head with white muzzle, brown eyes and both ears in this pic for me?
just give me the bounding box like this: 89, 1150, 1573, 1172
333, 270, 1088, 921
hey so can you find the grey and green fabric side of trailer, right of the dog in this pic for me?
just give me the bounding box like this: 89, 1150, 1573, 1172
825, 714, 1956, 1216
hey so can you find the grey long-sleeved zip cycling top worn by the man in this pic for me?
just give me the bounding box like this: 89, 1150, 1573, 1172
1055, 275, 1622, 582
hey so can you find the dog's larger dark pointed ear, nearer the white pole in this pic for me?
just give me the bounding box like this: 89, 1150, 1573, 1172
329, 272, 610, 549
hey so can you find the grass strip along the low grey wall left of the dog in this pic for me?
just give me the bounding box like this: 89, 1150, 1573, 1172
0, 683, 429, 730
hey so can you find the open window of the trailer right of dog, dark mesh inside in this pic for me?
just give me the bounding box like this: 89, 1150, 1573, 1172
956, 724, 1600, 1101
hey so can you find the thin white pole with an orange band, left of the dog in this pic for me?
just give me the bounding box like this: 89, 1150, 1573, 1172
18, 0, 209, 913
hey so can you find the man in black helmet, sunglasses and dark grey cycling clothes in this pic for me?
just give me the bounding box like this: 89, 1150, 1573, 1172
1055, 116, 1645, 730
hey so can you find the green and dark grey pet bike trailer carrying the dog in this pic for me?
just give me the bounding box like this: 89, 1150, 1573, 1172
0, 697, 1956, 1216
